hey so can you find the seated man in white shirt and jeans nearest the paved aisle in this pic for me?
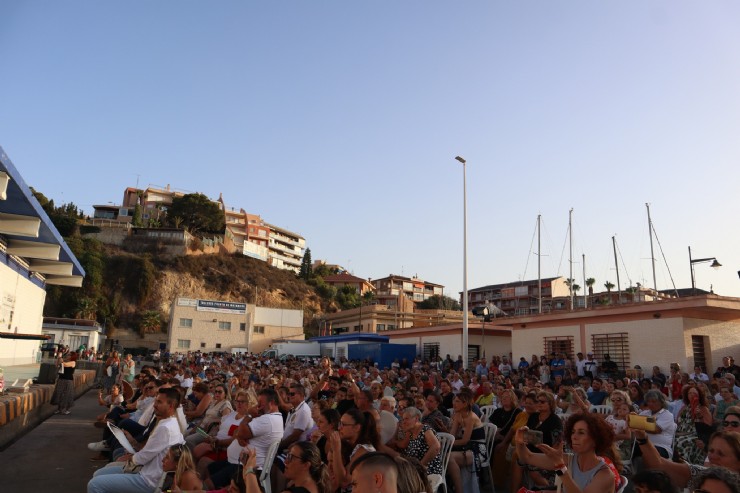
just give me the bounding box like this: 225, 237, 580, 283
87, 389, 184, 493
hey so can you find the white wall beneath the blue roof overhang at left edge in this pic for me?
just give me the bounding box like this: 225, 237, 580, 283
0, 262, 46, 366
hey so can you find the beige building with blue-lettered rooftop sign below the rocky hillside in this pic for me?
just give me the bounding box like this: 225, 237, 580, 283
167, 298, 305, 353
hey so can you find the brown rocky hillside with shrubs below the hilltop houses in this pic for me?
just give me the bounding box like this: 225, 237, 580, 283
44, 236, 336, 333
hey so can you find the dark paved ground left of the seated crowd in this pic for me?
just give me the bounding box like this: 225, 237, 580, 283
0, 386, 105, 493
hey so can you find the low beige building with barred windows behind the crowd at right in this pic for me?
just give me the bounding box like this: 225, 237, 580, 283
495, 295, 740, 373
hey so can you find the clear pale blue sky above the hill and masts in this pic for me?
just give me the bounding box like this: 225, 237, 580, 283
0, 0, 740, 297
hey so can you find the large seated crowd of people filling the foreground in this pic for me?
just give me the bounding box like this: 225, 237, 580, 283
73, 346, 740, 493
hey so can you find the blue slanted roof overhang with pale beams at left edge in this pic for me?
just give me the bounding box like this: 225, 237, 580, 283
0, 147, 85, 286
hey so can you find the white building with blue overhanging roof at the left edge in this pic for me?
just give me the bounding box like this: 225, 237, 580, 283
0, 147, 85, 366
